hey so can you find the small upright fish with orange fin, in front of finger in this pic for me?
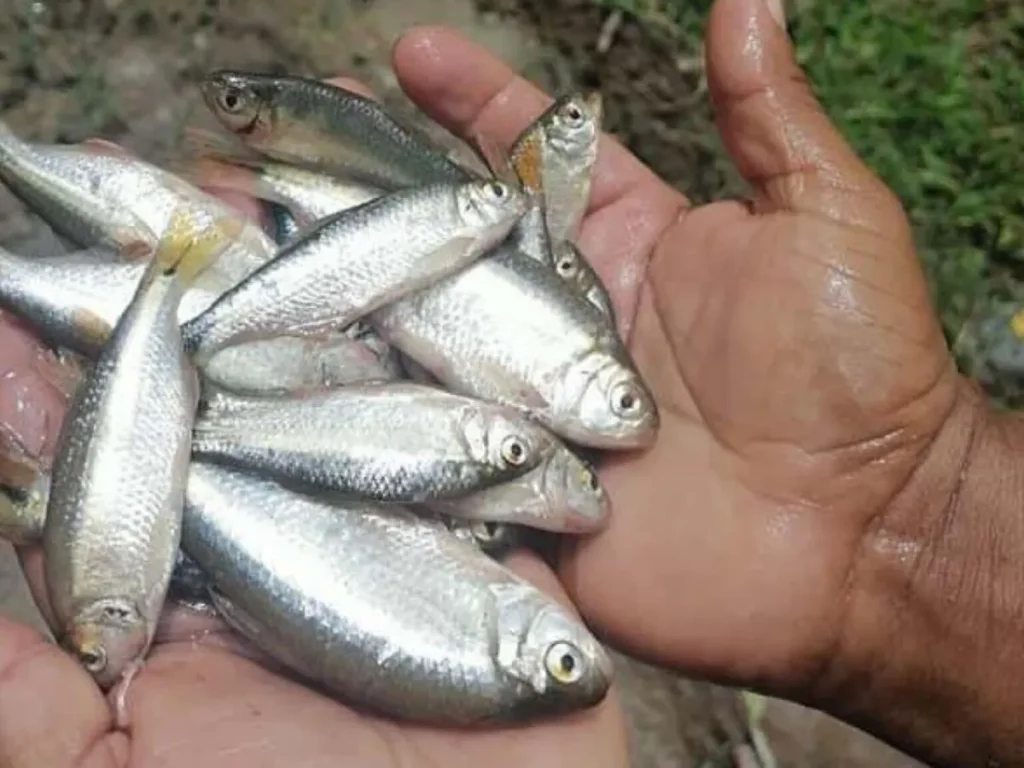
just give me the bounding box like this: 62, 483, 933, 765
509, 91, 603, 244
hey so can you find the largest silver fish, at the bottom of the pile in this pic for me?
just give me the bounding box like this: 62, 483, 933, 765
181, 461, 613, 727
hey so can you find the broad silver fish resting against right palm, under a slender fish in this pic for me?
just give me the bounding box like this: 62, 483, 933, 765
369, 245, 660, 450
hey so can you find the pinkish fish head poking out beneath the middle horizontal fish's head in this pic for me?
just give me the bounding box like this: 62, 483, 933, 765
541, 447, 611, 534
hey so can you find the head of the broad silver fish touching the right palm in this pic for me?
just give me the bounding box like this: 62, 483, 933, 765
552, 347, 660, 450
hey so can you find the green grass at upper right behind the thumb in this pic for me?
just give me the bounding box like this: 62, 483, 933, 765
595, 0, 1024, 407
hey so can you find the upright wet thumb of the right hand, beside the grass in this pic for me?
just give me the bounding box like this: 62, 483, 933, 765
707, 0, 891, 213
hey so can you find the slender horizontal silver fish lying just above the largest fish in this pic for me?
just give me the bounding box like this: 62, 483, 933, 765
193, 382, 557, 504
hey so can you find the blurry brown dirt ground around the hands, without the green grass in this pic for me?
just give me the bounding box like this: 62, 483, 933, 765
0, 0, 929, 768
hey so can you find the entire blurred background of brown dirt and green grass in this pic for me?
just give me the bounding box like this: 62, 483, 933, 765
0, 0, 1024, 768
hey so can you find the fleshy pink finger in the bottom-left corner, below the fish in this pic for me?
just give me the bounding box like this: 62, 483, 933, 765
0, 618, 128, 768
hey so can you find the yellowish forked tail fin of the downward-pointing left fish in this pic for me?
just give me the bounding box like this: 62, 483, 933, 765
153, 205, 246, 283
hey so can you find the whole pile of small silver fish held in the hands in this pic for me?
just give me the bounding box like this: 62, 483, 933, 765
0, 72, 658, 725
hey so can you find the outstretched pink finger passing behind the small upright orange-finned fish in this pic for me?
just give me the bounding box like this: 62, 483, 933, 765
393, 27, 688, 210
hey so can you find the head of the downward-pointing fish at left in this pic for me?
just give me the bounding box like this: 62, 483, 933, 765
63, 598, 151, 689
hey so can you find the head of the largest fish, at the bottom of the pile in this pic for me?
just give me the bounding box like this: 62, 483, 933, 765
499, 593, 614, 715
